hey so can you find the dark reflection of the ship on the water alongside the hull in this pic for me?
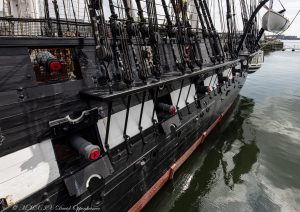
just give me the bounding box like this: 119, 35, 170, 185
145, 97, 259, 212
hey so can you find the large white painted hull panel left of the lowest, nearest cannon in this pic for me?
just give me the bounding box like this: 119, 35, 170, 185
0, 140, 60, 203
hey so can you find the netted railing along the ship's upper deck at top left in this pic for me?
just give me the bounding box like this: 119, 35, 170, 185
0, 17, 93, 37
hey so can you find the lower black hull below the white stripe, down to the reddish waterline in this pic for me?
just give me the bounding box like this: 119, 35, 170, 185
0, 70, 246, 211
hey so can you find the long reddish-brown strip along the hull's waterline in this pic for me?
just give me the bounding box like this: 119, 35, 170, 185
128, 102, 233, 212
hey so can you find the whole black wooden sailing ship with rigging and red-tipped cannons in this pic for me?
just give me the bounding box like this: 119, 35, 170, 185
0, 0, 268, 212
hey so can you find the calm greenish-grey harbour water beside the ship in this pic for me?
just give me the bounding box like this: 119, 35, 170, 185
144, 44, 300, 212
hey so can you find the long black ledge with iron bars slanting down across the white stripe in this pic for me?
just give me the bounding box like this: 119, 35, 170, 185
80, 59, 240, 157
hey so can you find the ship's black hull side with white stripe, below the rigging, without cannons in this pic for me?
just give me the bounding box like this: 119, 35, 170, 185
0, 38, 249, 211
